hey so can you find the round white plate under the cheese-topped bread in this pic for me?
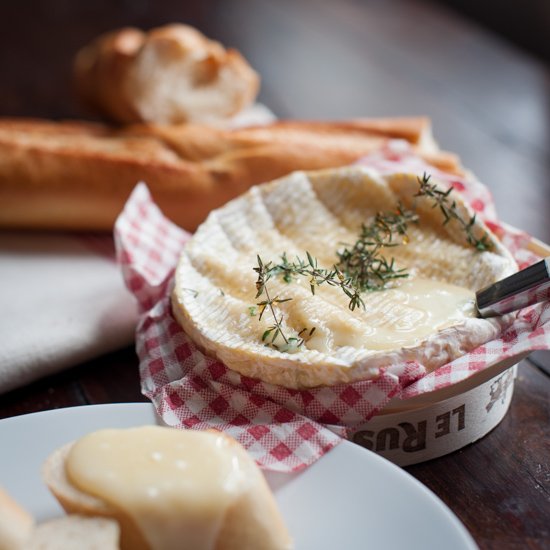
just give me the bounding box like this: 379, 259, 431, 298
0, 403, 477, 550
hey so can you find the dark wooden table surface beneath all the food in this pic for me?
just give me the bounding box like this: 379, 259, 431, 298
0, 0, 550, 549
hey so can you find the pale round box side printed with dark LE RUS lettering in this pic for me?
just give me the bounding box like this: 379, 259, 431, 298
349, 366, 517, 466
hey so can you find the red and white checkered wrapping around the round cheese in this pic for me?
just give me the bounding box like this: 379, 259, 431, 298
115, 142, 550, 472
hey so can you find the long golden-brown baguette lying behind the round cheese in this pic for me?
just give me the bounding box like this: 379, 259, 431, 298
0, 118, 460, 231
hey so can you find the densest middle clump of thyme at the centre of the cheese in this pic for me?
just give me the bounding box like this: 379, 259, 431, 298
336, 203, 418, 292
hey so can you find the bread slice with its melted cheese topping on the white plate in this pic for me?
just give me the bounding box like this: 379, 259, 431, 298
43, 426, 291, 550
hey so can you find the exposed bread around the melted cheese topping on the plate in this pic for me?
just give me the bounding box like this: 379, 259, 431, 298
43, 427, 291, 550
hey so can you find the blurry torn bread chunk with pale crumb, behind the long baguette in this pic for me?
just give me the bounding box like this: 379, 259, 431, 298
74, 24, 259, 123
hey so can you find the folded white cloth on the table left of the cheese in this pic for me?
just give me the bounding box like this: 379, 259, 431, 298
0, 231, 137, 393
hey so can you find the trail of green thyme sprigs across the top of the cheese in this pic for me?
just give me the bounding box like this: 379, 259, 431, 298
249, 173, 491, 352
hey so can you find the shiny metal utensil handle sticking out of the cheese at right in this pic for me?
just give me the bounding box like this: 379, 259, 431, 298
476, 256, 550, 317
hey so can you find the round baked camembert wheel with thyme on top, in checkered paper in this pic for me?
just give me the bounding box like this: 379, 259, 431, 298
172, 167, 517, 388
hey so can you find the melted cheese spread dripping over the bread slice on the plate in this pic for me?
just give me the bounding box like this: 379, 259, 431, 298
66, 426, 250, 550
